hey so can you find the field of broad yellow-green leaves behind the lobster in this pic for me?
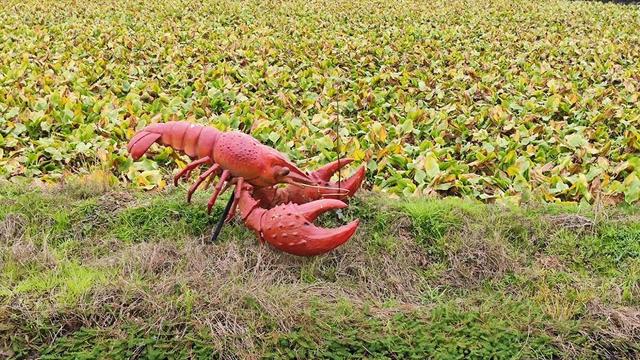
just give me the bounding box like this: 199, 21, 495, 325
0, 0, 640, 203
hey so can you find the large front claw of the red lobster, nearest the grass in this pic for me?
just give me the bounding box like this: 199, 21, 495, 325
259, 199, 360, 256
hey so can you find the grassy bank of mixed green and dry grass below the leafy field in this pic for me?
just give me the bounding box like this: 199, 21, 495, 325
0, 183, 640, 359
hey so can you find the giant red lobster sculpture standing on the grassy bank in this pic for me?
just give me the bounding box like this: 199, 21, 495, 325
127, 121, 365, 256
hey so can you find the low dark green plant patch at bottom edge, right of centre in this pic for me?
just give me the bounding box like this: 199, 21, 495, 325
266, 304, 557, 359
